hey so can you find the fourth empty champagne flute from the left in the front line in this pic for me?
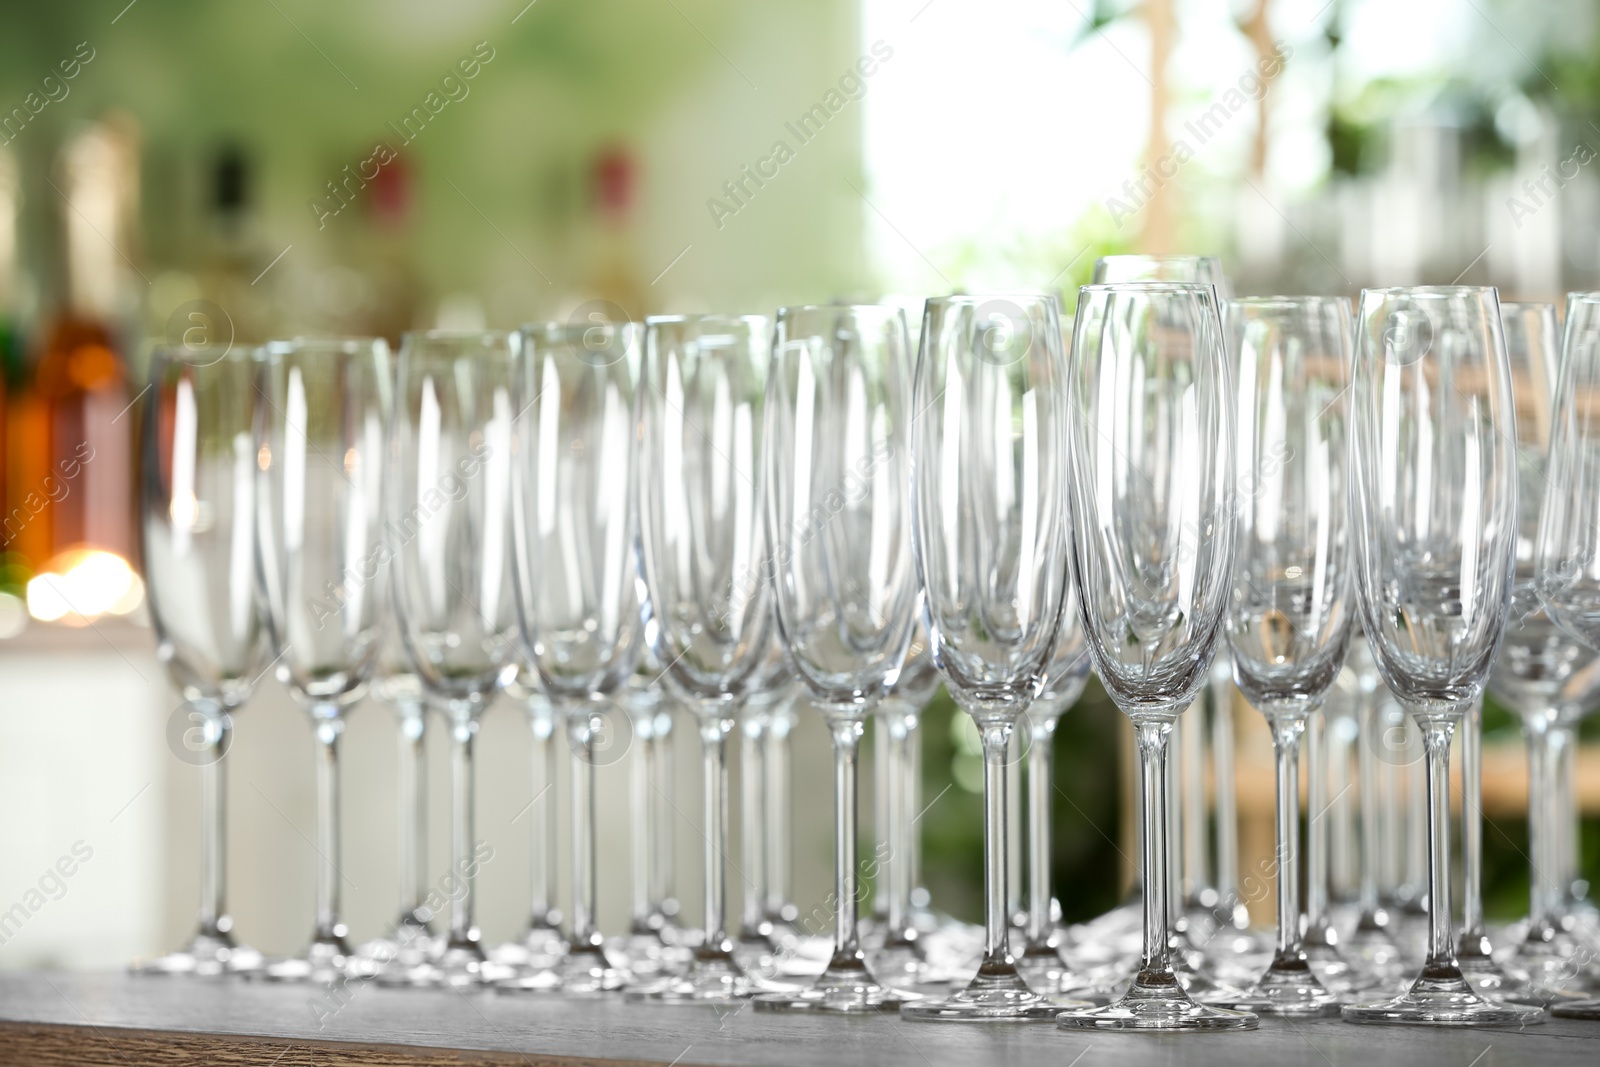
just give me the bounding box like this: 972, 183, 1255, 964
512, 323, 643, 993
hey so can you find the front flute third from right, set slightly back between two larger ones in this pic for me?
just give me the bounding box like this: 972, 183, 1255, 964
1214, 296, 1354, 1017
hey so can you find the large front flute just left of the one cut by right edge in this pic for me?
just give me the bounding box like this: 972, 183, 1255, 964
1344, 286, 1542, 1025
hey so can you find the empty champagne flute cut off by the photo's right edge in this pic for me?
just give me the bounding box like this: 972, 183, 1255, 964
1533, 293, 1600, 1019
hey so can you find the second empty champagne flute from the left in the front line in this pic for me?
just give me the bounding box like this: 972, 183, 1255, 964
256, 338, 394, 982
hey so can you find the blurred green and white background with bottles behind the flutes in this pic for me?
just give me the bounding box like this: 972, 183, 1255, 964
0, 0, 1600, 968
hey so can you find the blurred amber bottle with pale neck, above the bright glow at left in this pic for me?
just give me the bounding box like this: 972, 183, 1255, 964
23, 118, 142, 624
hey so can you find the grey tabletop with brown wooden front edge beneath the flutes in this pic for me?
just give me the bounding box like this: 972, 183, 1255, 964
0, 973, 1600, 1067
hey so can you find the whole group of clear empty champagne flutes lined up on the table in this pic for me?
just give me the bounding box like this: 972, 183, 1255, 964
131, 252, 1600, 1029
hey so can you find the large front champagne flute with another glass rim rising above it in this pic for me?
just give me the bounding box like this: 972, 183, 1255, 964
1058, 282, 1256, 1030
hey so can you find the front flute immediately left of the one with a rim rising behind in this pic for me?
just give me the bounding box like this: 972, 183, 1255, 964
901, 293, 1070, 1021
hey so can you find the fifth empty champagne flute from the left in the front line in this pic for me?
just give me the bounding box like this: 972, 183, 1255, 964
638, 315, 773, 1005
